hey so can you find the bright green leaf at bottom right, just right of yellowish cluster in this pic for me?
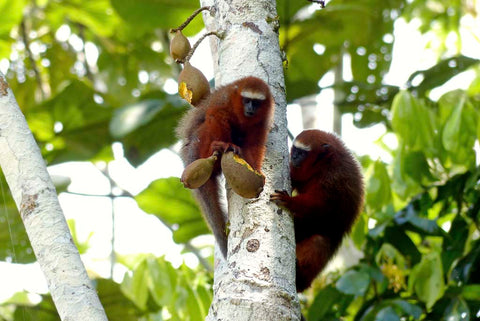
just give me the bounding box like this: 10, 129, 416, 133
408, 252, 445, 309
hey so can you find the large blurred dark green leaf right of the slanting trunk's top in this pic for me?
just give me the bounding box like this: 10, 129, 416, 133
27, 80, 112, 164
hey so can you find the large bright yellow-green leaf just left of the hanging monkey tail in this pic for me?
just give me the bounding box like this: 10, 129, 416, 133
135, 177, 210, 242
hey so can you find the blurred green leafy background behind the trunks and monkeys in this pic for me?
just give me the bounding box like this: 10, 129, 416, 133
0, 0, 480, 321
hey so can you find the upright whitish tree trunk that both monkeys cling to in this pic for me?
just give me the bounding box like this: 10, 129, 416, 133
199, 0, 300, 321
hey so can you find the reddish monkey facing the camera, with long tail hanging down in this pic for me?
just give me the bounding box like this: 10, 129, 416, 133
177, 77, 274, 257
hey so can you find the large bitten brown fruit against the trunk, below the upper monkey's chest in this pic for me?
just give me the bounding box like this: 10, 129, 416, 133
221, 152, 265, 198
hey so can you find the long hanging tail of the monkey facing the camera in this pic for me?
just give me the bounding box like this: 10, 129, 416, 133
193, 176, 227, 258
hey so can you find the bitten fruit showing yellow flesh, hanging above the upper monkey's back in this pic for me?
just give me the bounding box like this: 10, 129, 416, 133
178, 61, 210, 106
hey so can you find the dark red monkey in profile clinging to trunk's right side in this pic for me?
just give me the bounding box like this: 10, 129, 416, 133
270, 129, 364, 292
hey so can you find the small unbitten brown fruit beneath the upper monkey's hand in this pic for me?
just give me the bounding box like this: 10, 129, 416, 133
180, 155, 217, 189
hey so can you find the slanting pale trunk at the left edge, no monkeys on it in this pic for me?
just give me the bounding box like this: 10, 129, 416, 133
0, 73, 107, 321
